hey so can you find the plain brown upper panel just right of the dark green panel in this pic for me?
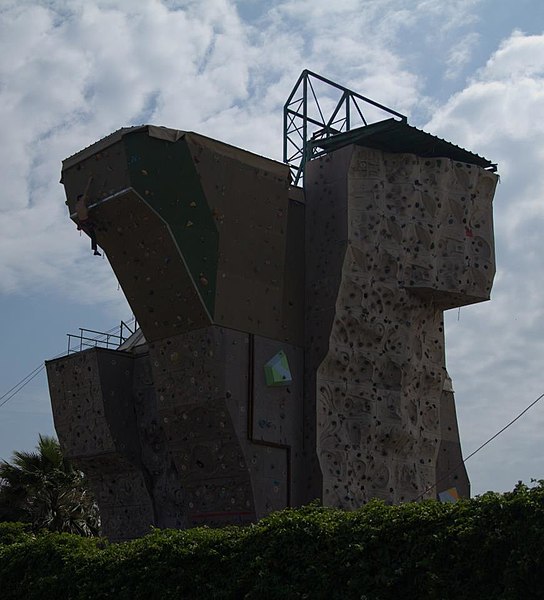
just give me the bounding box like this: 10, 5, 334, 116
187, 135, 294, 344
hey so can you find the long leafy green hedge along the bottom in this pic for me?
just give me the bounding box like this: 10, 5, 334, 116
0, 481, 544, 600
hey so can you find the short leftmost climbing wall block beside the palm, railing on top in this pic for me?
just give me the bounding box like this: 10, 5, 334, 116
47, 349, 154, 540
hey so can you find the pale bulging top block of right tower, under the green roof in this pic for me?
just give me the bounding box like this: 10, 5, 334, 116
370, 147, 498, 310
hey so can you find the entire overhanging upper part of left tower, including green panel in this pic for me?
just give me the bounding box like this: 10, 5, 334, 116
62, 126, 304, 346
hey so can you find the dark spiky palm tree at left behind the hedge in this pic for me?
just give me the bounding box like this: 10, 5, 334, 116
0, 435, 100, 536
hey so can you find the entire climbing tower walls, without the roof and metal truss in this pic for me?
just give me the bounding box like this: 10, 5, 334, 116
47, 129, 496, 539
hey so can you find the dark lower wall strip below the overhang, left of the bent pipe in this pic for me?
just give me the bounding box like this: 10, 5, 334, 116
149, 327, 255, 525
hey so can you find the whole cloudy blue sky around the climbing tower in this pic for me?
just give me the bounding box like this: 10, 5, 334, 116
0, 0, 544, 493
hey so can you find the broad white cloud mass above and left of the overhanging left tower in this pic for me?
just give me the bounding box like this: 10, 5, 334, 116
0, 0, 442, 300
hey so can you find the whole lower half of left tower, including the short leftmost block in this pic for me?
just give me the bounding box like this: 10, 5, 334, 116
47, 326, 311, 540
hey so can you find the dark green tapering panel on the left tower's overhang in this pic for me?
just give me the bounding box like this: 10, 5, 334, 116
123, 131, 219, 320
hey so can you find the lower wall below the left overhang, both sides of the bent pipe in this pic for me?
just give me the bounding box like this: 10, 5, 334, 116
149, 326, 305, 525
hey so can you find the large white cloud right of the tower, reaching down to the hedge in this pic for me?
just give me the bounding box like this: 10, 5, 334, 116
427, 32, 544, 489
